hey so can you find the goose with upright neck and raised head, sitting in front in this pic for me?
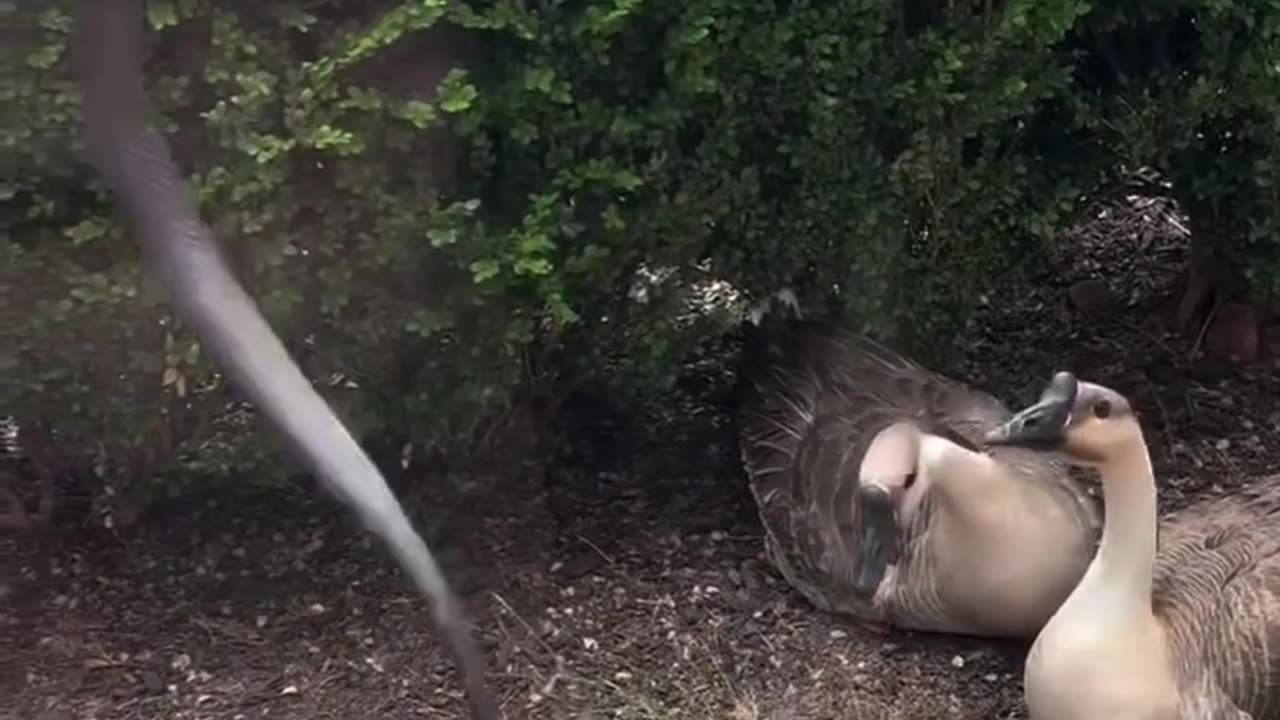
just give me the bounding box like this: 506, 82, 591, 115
984, 372, 1280, 720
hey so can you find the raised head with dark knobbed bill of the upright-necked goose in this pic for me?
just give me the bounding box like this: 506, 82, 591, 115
983, 370, 1143, 468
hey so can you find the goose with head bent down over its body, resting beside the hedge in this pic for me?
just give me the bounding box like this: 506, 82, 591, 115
739, 294, 1102, 641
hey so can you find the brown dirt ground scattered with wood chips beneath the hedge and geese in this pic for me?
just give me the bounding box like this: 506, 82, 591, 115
0, 193, 1280, 720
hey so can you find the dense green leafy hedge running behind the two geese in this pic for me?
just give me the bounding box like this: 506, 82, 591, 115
0, 0, 1277, 515
